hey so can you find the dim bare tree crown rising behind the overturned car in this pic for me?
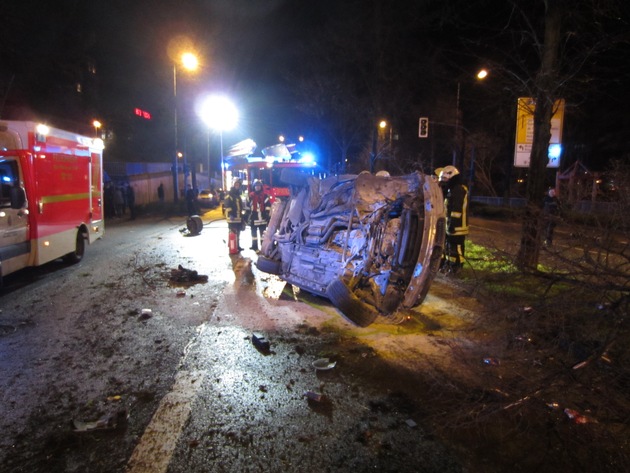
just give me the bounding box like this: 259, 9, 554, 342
291, 0, 450, 170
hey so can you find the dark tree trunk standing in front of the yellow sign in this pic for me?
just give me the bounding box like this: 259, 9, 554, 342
516, 0, 562, 269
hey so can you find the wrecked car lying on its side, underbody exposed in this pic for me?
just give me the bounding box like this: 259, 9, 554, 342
256, 170, 445, 327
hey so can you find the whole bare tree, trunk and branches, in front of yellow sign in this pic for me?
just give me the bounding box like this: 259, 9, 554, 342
469, 0, 628, 268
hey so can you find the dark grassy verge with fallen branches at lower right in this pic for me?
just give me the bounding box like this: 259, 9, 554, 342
425, 235, 630, 472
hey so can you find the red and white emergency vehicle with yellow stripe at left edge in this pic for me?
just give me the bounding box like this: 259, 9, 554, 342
0, 120, 104, 278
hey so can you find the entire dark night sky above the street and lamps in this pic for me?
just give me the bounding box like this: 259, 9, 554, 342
0, 0, 630, 173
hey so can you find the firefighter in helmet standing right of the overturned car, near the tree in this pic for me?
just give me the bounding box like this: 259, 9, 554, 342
435, 166, 468, 273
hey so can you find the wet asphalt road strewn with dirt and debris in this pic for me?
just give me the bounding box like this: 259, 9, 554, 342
0, 213, 467, 473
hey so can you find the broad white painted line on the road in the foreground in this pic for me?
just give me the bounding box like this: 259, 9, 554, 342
127, 371, 205, 473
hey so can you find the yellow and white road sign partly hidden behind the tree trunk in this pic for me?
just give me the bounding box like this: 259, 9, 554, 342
514, 97, 564, 168
